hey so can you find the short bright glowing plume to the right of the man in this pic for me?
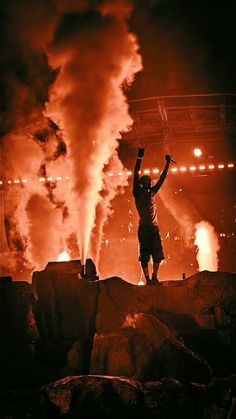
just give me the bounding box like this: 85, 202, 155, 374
194, 221, 220, 271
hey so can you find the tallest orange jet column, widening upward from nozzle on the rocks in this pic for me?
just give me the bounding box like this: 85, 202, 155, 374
47, 2, 142, 264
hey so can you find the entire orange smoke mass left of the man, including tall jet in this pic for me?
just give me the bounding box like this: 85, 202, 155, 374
0, 0, 141, 278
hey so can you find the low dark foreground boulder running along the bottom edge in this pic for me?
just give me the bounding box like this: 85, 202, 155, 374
0, 375, 236, 419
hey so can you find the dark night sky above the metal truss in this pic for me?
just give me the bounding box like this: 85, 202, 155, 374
128, 0, 236, 97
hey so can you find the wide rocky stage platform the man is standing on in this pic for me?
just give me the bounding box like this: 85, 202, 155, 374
0, 270, 236, 418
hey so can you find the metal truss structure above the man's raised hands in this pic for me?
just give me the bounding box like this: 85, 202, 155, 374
123, 94, 236, 145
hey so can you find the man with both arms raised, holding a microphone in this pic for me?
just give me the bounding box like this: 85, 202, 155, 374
133, 147, 171, 285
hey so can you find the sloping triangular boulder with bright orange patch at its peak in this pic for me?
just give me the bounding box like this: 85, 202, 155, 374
90, 313, 211, 383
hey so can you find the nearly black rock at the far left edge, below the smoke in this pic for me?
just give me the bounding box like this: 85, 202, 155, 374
0, 281, 40, 389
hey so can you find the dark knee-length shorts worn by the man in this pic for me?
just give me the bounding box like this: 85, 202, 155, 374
138, 224, 164, 263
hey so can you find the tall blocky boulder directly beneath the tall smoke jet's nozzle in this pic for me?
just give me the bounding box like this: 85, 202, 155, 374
32, 269, 98, 374
